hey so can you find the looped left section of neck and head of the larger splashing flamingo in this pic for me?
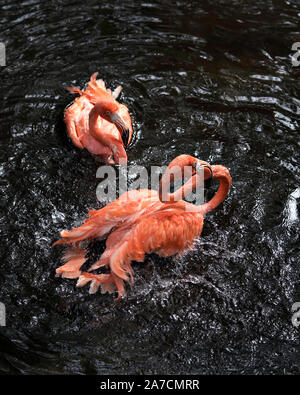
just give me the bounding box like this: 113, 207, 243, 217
158, 155, 211, 203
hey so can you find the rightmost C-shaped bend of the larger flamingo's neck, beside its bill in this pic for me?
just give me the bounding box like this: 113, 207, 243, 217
197, 165, 231, 215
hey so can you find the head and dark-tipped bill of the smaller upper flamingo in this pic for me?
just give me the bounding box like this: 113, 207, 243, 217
95, 100, 130, 147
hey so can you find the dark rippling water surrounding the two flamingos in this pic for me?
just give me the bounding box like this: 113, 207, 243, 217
0, 0, 300, 374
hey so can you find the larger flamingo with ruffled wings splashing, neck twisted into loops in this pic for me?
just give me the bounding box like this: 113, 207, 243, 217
54, 155, 231, 299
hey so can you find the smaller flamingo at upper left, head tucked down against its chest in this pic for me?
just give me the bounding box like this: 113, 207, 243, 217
64, 73, 133, 164
